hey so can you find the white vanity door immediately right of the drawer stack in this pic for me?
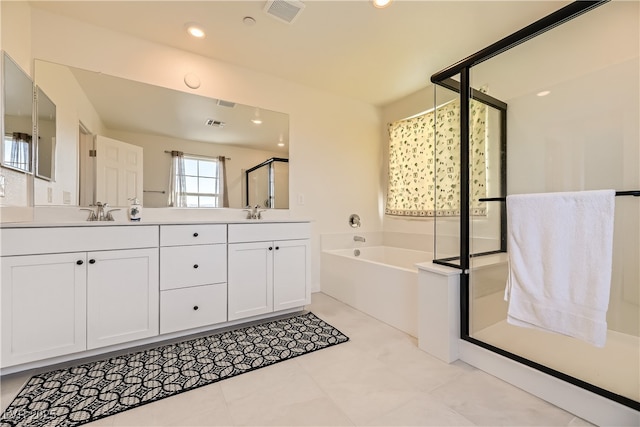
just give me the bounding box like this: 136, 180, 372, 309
227, 242, 274, 320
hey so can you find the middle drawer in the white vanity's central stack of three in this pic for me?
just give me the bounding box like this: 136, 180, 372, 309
160, 245, 227, 290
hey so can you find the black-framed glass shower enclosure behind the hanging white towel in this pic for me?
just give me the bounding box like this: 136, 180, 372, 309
432, 2, 640, 410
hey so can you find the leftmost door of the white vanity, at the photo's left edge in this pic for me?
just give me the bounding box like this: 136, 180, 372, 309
1, 252, 86, 367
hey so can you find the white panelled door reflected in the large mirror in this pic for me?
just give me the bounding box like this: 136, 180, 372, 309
96, 135, 143, 206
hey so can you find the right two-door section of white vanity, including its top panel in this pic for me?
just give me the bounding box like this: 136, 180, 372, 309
228, 222, 311, 320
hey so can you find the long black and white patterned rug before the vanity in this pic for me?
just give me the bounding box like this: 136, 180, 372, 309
0, 313, 349, 427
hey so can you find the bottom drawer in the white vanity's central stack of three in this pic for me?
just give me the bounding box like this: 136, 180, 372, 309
160, 283, 227, 334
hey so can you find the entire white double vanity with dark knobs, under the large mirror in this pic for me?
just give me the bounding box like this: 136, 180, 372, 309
0, 220, 311, 373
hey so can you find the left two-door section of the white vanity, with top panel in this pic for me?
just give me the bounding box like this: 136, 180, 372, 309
0, 226, 159, 367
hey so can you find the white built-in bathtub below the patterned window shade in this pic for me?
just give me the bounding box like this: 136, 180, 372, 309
320, 246, 433, 337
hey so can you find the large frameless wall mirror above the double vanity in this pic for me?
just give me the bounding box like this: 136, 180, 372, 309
35, 59, 289, 208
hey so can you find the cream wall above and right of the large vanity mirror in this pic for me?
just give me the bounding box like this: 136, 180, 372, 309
26, 9, 381, 290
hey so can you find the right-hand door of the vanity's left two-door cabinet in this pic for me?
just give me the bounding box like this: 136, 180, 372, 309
87, 249, 160, 349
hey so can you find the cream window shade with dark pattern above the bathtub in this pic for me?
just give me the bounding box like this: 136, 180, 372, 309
385, 100, 487, 217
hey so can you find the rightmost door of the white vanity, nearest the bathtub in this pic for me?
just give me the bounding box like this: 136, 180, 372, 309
273, 240, 311, 311
